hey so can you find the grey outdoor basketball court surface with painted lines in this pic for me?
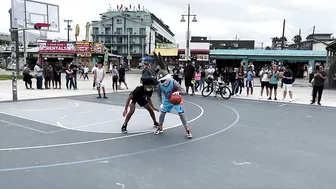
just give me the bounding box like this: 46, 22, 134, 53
0, 93, 336, 189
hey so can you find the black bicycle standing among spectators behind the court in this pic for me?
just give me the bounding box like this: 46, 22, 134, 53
202, 78, 231, 99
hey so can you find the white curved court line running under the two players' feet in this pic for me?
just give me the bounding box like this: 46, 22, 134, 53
0, 100, 204, 151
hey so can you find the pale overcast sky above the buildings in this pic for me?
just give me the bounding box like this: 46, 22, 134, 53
0, 0, 336, 46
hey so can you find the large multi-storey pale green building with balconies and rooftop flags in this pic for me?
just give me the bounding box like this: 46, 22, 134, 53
91, 9, 175, 57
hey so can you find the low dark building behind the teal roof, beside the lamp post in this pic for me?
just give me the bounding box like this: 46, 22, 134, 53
190, 36, 255, 50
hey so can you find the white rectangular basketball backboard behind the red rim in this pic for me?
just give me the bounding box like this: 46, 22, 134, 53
11, 0, 60, 32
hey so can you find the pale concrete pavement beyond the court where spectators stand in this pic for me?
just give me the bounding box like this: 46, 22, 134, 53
0, 73, 336, 107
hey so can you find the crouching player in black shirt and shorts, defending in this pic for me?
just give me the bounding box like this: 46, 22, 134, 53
121, 78, 159, 133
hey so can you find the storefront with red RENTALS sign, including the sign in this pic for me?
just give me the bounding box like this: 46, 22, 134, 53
38, 42, 75, 66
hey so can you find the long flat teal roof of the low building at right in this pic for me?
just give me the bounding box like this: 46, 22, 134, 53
210, 49, 327, 56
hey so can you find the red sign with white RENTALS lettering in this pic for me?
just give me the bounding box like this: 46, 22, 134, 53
39, 42, 75, 53
